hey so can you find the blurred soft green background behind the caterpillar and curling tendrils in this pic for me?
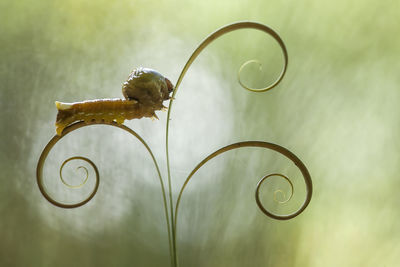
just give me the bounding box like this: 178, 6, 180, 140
0, 0, 400, 267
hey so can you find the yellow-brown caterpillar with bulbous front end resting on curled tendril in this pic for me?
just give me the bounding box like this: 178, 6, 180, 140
55, 67, 174, 135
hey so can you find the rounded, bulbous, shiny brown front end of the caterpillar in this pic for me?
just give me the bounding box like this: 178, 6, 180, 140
122, 67, 174, 109
